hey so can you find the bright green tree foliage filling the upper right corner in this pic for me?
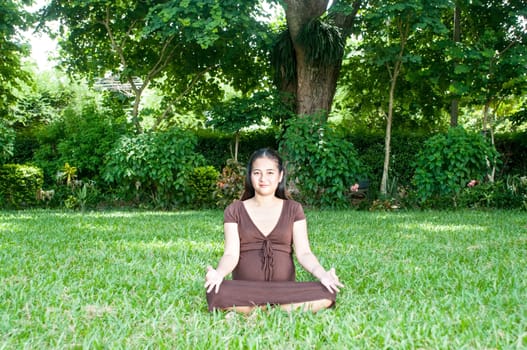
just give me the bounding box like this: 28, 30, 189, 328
334, 0, 527, 132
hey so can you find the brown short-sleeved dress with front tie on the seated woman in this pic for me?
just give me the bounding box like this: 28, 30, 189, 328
207, 200, 336, 311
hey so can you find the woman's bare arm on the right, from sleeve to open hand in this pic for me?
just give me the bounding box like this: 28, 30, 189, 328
293, 220, 344, 293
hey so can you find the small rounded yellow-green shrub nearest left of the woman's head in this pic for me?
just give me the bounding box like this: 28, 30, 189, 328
188, 165, 220, 209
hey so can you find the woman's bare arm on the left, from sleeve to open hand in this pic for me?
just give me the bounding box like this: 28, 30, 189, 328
205, 222, 240, 293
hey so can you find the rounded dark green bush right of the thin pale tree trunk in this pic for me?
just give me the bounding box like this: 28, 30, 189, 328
413, 127, 498, 202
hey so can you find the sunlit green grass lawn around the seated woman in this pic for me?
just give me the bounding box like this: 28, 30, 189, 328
0, 211, 527, 349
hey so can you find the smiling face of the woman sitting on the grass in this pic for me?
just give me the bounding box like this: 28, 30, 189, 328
251, 157, 283, 195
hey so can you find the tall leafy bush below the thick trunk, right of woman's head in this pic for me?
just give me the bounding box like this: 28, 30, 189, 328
280, 116, 364, 208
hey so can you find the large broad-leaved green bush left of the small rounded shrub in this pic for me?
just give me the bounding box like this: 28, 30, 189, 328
104, 128, 204, 208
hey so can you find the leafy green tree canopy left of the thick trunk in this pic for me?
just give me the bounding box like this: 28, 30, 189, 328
44, 0, 267, 130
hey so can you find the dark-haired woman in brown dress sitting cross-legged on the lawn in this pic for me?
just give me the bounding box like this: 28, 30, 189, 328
205, 148, 343, 313
